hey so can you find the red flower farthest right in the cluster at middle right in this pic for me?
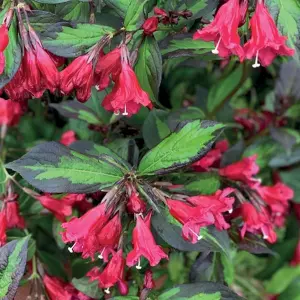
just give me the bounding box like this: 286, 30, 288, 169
256, 182, 294, 227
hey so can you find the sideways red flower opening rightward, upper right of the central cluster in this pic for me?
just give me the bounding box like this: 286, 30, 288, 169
188, 188, 235, 230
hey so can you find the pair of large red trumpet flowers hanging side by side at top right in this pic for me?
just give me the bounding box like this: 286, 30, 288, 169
194, 0, 295, 68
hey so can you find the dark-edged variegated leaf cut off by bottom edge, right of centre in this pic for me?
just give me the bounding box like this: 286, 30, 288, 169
158, 281, 242, 300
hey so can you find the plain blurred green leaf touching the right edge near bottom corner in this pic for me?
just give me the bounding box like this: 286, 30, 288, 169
265, 266, 300, 295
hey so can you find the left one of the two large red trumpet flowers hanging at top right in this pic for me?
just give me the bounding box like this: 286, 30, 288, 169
193, 0, 245, 62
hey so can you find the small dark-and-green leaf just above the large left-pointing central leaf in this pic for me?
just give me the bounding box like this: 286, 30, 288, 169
50, 101, 102, 125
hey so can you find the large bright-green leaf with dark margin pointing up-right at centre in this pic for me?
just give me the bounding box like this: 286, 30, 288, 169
138, 120, 223, 175
